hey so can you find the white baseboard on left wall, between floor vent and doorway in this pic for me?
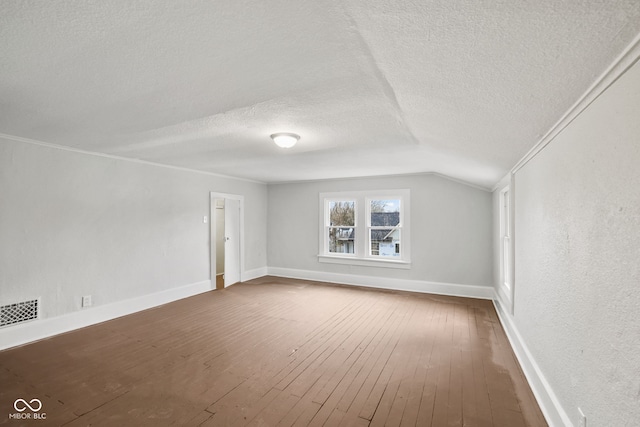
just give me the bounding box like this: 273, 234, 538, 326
0, 280, 212, 350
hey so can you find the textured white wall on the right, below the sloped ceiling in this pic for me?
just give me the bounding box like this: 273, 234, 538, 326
495, 58, 640, 426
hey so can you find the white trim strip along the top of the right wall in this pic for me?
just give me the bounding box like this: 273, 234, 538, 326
492, 34, 640, 191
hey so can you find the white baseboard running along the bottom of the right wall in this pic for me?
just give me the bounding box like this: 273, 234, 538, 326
493, 298, 573, 427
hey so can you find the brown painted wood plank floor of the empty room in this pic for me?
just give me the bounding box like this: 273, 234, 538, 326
0, 277, 546, 427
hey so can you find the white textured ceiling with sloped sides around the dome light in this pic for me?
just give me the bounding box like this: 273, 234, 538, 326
0, 0, 640, 187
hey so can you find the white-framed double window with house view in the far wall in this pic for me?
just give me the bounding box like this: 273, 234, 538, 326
318, 190, 410, 268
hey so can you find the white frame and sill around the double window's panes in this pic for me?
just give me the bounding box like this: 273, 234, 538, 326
318, 189, 411, 269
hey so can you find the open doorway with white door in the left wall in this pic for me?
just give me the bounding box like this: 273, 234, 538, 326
210, 193, 244, 289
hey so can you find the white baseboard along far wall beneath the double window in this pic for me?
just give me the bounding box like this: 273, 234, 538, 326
267, 267, 494, 299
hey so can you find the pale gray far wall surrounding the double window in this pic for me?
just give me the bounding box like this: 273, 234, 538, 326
268, 174, 493, 286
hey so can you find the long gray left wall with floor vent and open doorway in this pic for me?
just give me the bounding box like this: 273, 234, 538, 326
0, 139, 267, 318
